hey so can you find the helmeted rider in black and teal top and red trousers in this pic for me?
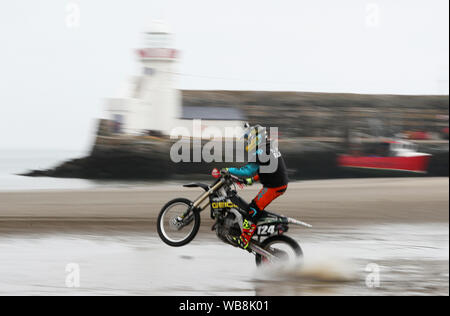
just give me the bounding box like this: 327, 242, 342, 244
222, 123, 289, 249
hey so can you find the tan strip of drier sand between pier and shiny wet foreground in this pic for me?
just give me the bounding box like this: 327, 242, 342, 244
0, 178, 449, 226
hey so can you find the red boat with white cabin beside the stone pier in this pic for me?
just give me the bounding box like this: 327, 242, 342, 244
338, 141, 431, 173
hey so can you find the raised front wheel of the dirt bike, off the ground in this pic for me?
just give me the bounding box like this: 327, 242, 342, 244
157, 198, 200, 247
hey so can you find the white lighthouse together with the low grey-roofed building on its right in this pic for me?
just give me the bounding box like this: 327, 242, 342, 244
106, 21, 246, 138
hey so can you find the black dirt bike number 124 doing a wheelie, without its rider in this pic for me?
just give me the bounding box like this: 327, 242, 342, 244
157, 169, 311, 266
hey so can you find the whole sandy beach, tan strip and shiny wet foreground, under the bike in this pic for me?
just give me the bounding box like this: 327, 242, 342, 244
0, 178, 449, 295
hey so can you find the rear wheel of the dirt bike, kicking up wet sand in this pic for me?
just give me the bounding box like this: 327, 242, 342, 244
255, 235, 303, 266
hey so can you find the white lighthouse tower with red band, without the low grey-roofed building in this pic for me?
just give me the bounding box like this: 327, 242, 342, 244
107, 21, 181, 135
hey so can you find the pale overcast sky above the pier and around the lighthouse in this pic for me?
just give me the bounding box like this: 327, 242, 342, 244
0, 0, 449, 150
